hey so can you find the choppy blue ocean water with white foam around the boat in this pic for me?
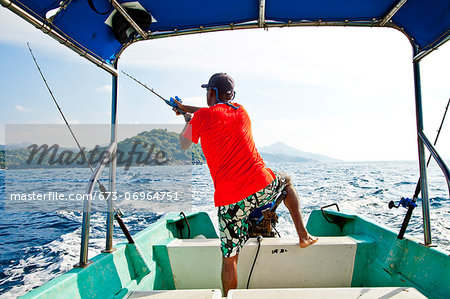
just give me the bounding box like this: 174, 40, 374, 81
0, 162, 450, 298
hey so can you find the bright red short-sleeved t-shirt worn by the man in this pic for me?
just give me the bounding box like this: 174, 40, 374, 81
183, 103, 275, 207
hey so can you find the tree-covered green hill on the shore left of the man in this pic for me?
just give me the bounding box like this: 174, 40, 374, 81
0, 129, 205, 169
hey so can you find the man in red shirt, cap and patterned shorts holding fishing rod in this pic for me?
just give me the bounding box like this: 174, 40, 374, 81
177, 73, 317, 296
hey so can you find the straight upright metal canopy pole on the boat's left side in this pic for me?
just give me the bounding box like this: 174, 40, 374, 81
102, 59, 119, 253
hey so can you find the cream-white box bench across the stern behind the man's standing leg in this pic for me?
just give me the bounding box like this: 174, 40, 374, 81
167, 236, 359, 289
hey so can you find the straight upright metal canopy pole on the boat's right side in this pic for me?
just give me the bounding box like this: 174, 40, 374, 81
413, 45, 431, 246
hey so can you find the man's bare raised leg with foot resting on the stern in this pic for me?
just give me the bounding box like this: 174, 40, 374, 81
284, 176, 317, 248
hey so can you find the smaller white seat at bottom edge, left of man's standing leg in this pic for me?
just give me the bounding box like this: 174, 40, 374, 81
125, 290, 222, 299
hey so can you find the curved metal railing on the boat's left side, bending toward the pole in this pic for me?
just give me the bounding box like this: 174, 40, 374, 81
75, 141, 117, 268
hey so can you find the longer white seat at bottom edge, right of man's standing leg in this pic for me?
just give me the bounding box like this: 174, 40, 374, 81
227, 287, 426, 299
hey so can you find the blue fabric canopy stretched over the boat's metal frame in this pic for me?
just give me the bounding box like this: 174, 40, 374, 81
0, 0, 450, 73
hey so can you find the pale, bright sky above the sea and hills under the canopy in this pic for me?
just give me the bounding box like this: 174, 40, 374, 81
0, 7, 450, 164
